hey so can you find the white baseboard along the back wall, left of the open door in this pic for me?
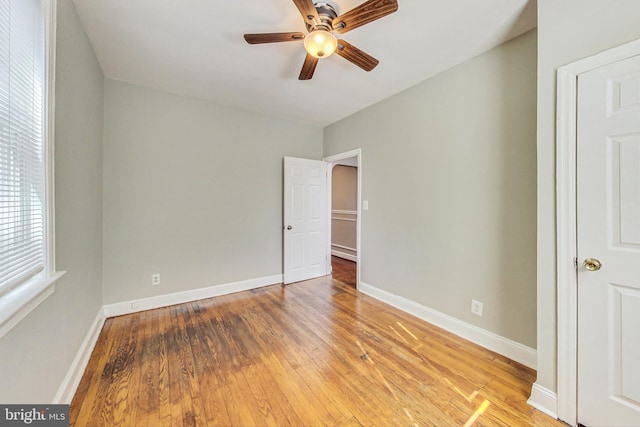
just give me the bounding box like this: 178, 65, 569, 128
104, 274, 282, 317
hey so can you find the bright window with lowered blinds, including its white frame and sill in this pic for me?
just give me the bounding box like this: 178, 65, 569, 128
0, 0, 57, 336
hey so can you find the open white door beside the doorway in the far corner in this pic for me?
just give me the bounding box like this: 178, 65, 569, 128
283, 157, 328, 284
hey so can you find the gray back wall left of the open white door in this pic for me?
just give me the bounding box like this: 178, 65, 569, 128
103, 79, 322, 304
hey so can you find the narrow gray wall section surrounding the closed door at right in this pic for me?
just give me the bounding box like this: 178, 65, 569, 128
537, 0, 640, 391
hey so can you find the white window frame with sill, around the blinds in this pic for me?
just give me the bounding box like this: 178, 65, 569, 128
0, 0, 65, 337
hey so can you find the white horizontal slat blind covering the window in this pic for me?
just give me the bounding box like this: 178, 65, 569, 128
0, 0, 46, 295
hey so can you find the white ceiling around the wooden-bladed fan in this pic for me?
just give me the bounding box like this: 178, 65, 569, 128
74, 0, 536, 126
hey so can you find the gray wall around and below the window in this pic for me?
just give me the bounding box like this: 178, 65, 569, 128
0, 0, 103, 403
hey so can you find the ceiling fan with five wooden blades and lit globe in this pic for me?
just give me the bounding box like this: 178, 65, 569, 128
244, 0, 398, 80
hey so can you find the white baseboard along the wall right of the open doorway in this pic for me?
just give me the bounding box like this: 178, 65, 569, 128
358, 282, 537, 369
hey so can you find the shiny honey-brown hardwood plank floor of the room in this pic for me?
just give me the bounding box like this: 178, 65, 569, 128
70, 277, 563, 427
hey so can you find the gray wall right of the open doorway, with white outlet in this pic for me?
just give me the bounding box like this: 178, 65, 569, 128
324, 31, 536, 347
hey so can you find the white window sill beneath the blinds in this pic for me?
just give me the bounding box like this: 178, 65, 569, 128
0, 271, 66, 338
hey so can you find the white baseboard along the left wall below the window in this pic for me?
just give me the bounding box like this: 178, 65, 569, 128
53, 310, 105, 404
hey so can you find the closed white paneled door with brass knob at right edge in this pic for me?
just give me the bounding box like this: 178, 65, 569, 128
577, 57, 640, 426
